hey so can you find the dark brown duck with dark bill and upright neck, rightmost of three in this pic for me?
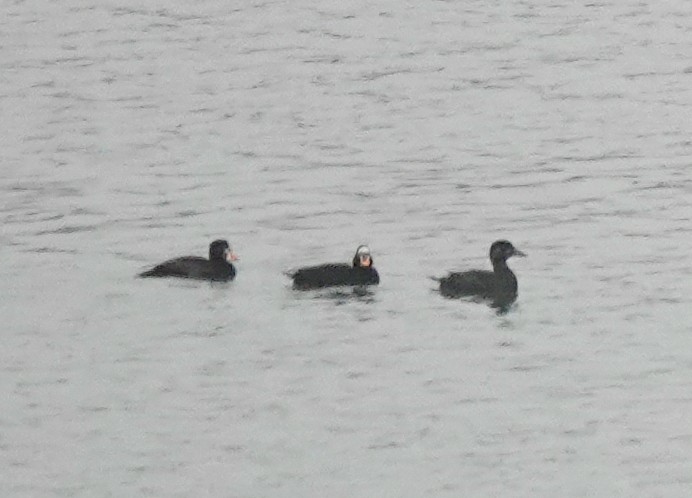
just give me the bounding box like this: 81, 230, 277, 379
435, 240, 526, 308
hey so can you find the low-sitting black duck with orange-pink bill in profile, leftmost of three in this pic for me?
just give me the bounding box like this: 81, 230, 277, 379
139, 239, 238, 282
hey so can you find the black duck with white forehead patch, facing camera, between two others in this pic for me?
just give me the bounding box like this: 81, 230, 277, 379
287, 245, 380, 290
